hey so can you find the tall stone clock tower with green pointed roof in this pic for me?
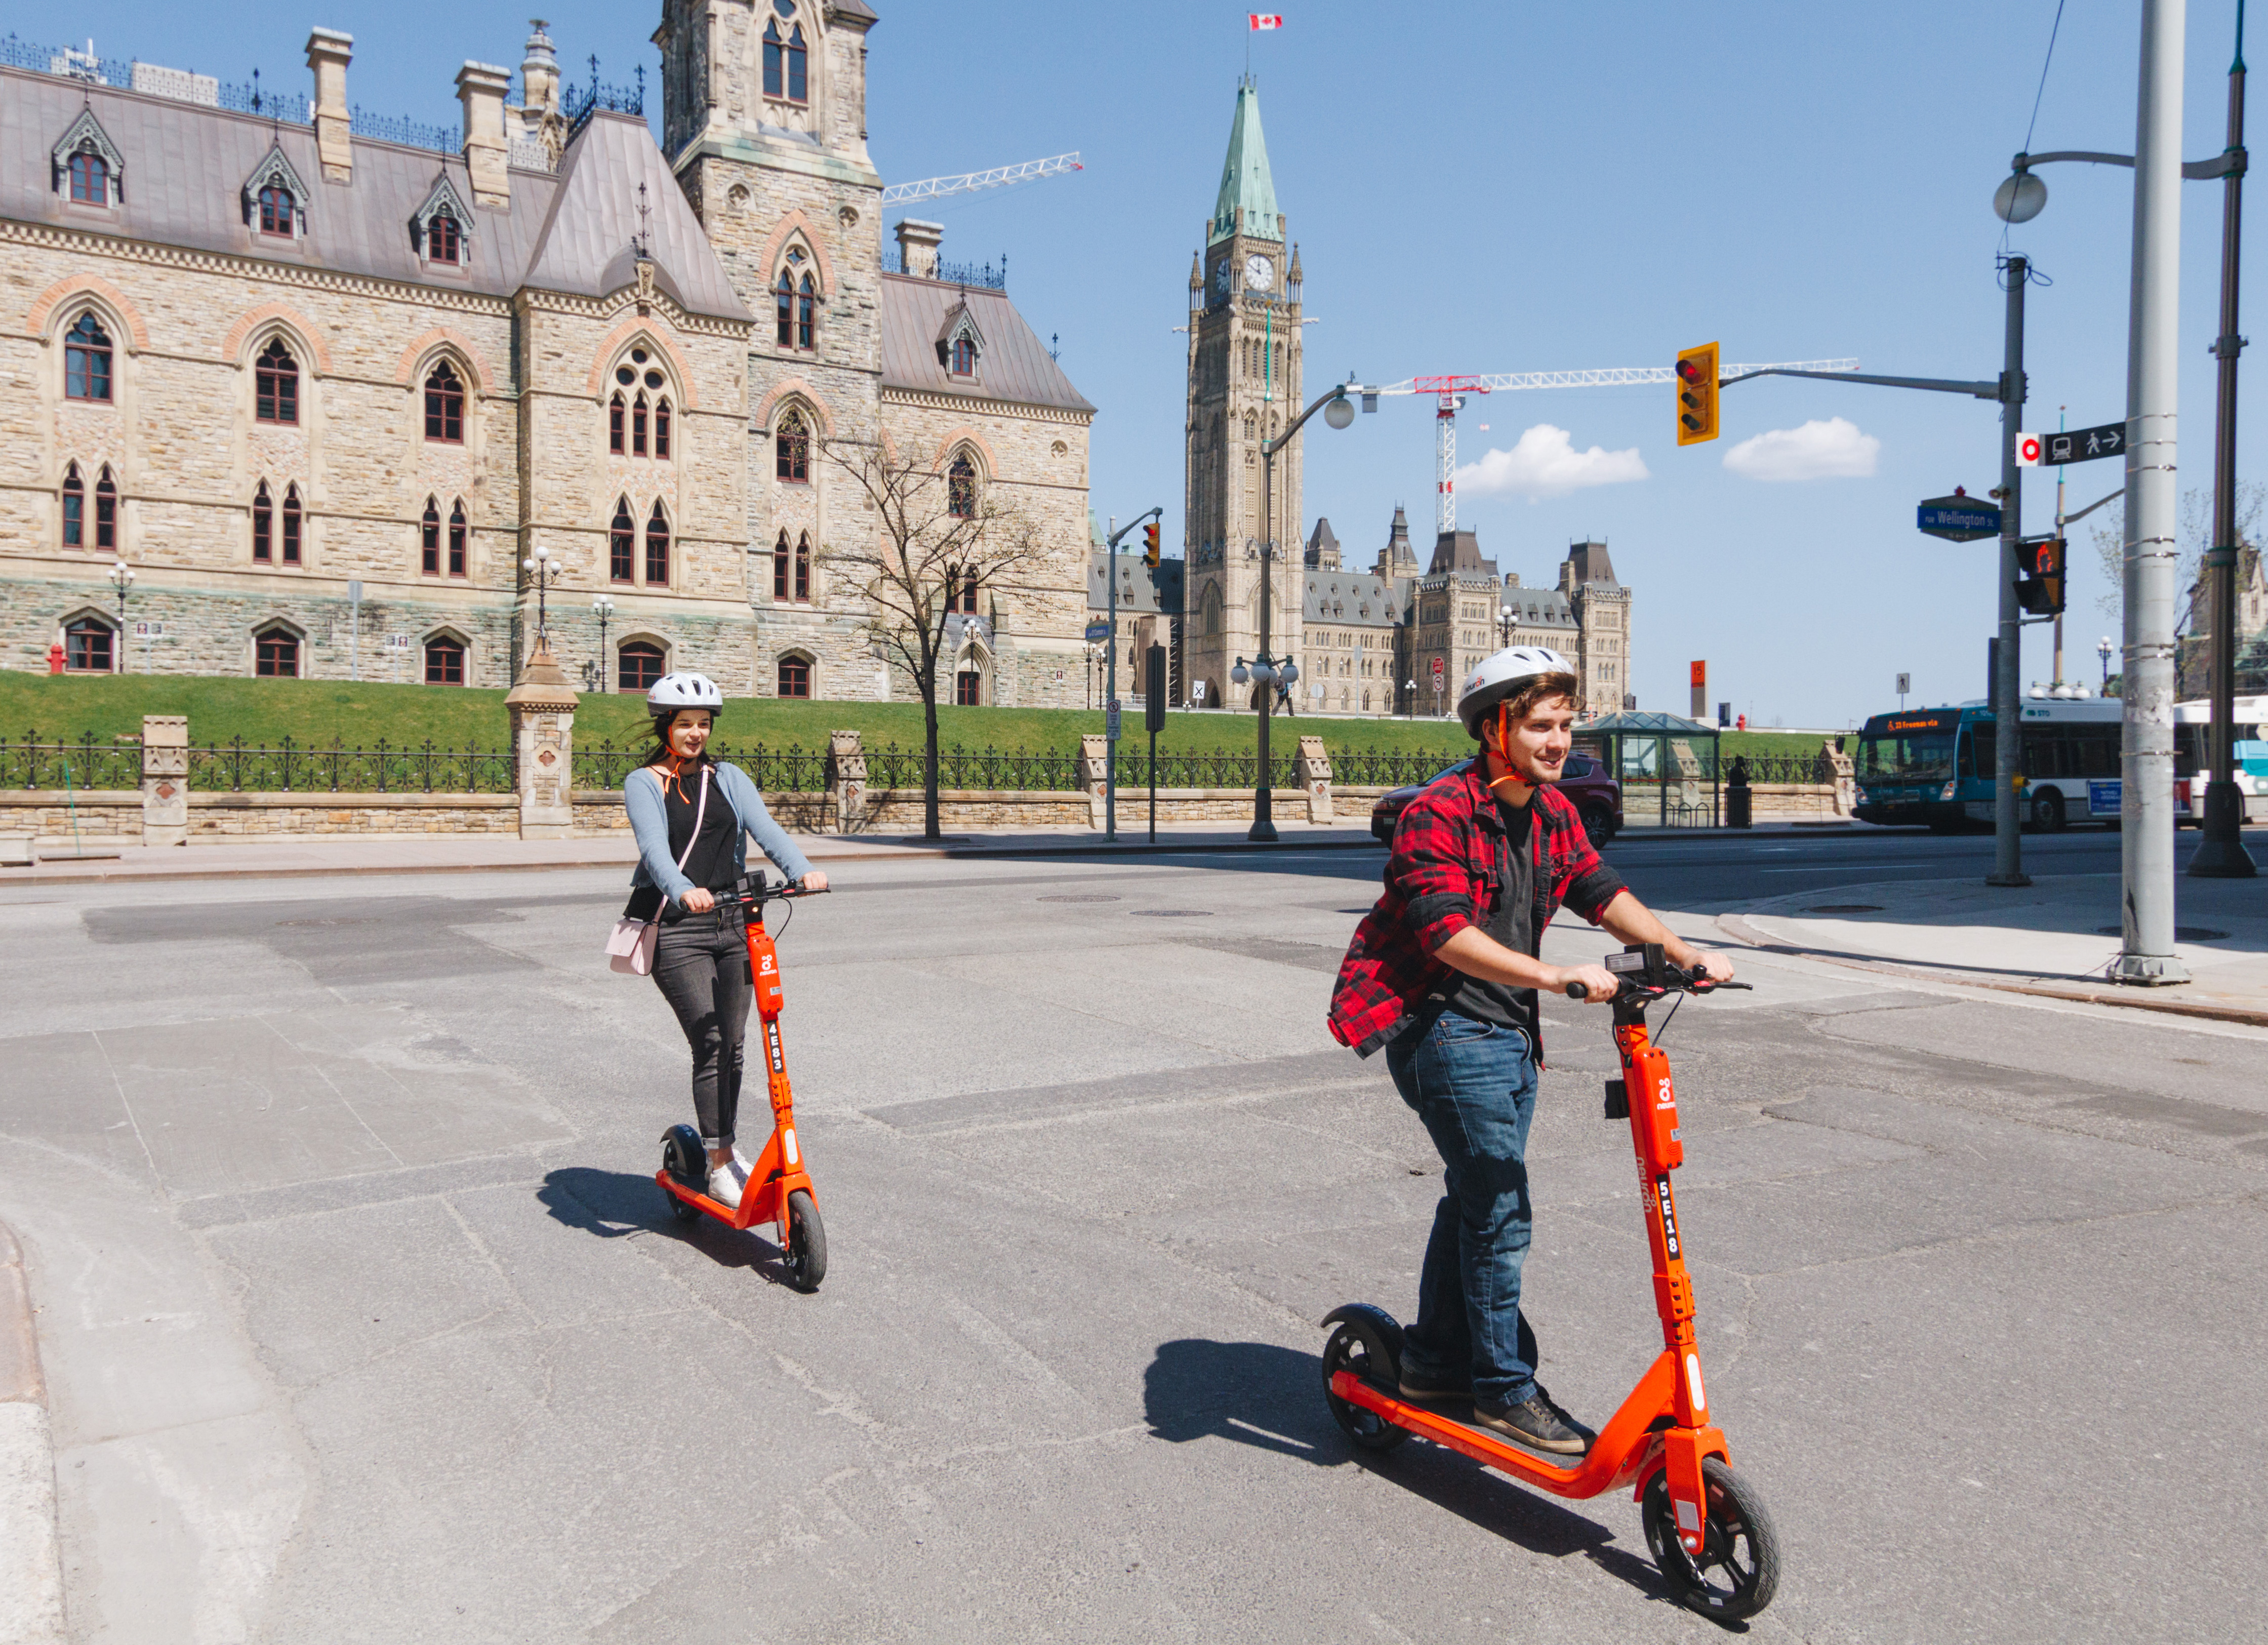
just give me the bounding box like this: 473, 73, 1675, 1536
1182, 77, 1304, 708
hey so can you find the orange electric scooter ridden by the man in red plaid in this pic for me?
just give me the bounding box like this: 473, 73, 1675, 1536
1322, 944, 1780, 1620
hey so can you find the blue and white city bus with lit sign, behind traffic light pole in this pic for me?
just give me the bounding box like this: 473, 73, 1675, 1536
1853, 697, 2132, 833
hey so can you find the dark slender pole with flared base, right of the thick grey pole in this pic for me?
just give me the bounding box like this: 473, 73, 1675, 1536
2189, 0, 2259, 880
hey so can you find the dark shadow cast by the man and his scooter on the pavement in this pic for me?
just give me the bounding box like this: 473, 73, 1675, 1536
1143, 1337, 1676, 1604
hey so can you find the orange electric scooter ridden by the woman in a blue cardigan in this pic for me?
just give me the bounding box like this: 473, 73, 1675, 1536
653, 873, 828, 1291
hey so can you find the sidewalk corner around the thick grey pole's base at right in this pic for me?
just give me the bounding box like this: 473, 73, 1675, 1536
1717, 873, 2268, 1028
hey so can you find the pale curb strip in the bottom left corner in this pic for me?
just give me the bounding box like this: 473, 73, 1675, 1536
0, 1223, 63, 1645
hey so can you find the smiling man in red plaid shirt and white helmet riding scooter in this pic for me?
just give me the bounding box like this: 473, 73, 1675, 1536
1329, 647, 1733, 1455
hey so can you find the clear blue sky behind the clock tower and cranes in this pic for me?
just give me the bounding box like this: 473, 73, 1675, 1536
57, 0, 2268, 726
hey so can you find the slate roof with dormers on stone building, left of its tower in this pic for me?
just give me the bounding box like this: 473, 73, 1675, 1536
0, 68, 748, 320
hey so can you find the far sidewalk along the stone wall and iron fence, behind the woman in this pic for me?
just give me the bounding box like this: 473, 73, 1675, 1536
0, 819, 1374, 890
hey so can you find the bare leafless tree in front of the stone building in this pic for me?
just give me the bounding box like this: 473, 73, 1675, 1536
819, 433, 1041, 839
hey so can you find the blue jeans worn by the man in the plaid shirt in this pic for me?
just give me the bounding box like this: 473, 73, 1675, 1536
1386, 1012, 1535, 1405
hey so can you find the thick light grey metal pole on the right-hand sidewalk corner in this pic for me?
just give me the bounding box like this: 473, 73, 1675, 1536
2109, 0, 2189, 985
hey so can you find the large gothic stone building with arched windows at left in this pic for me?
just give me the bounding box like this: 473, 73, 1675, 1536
0, 13, 1093, 703
